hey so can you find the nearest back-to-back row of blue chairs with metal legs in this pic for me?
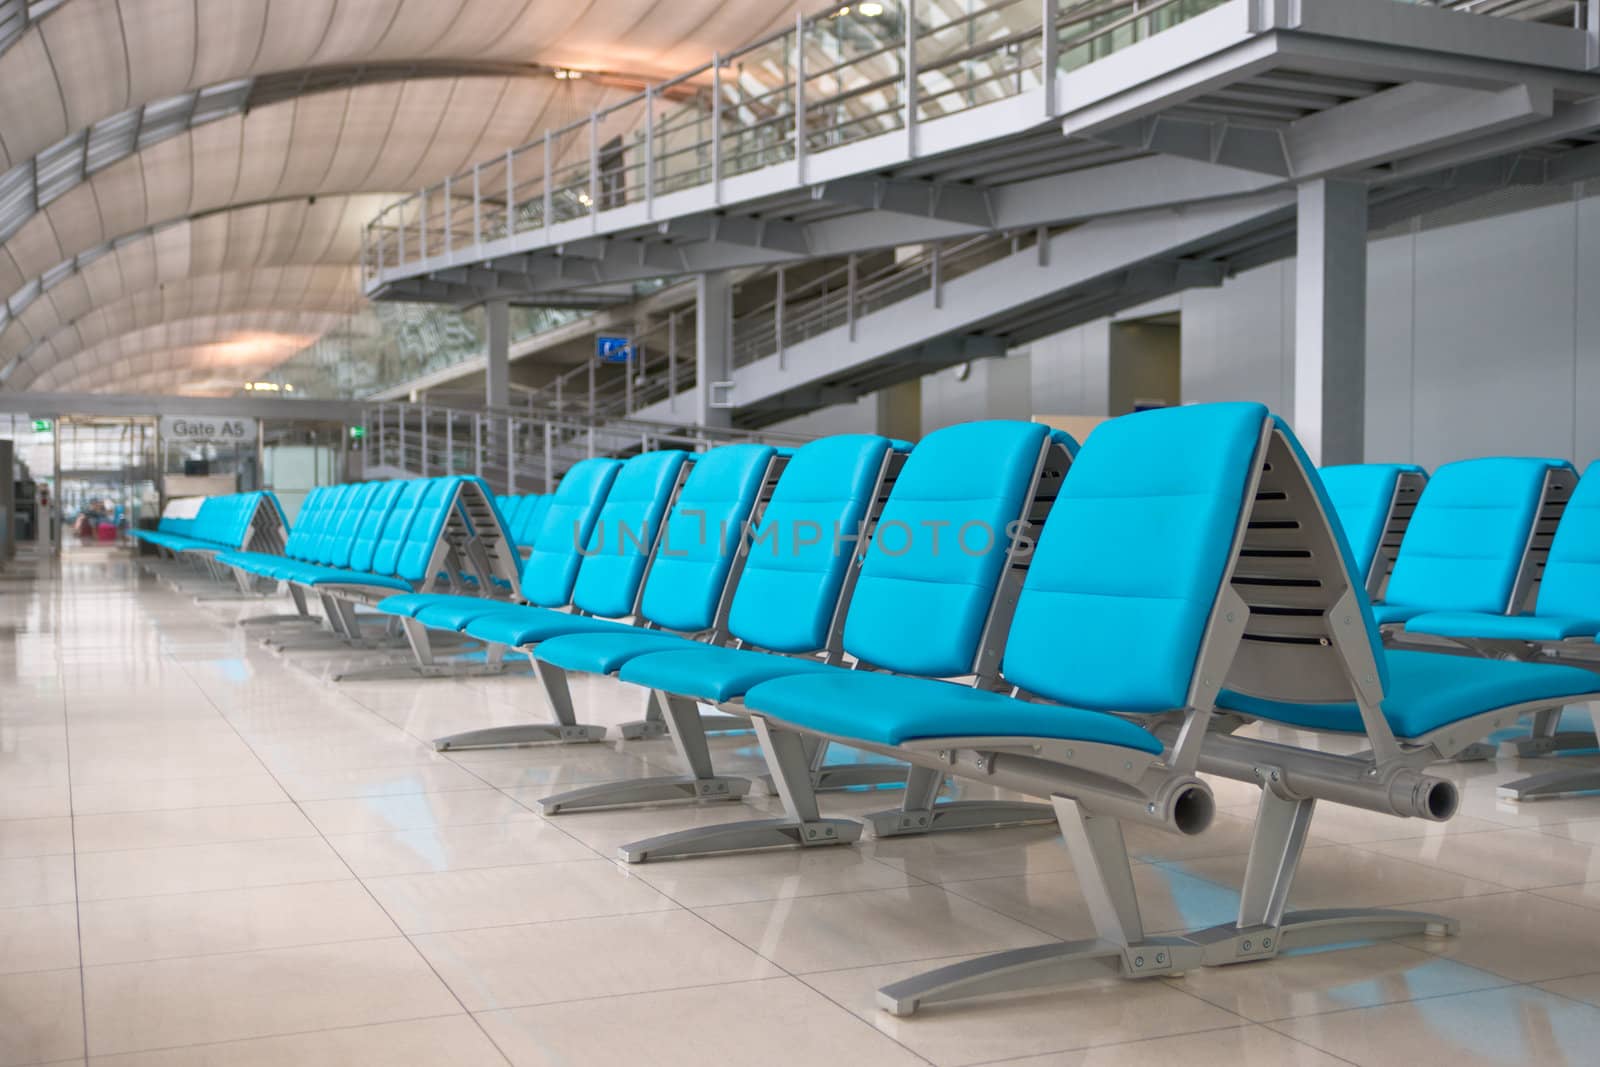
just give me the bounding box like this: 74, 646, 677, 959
275, 403, 1600, 1014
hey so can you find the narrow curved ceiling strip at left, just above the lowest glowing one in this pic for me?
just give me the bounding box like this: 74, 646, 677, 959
6, 264, 362, 389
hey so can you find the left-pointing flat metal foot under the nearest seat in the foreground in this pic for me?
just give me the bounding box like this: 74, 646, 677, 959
878, 937, 1200, 1016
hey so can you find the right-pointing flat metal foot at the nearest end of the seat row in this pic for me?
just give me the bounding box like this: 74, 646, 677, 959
1186, 907, 1461, 966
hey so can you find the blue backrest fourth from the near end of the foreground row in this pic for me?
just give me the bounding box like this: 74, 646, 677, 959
638, 445, 780, 632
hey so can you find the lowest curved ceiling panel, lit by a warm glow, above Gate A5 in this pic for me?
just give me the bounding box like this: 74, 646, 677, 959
30, 310, 347, 394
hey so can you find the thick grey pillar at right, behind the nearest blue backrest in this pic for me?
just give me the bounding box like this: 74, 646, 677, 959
1294, 179, 1366, 466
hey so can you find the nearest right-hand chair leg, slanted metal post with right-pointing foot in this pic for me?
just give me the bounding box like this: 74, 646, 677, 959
1187, 789, 1458, 966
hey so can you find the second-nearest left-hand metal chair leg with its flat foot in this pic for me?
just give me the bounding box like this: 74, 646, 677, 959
618, 717, 861, 864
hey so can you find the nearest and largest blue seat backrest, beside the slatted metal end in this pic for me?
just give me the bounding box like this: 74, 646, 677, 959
1004, 403, 1269, 712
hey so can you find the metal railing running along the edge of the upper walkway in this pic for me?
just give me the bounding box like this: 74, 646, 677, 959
362, 0, 1226, 280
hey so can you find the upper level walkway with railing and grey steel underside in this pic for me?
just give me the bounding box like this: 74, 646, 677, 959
363, 0, 1600, 302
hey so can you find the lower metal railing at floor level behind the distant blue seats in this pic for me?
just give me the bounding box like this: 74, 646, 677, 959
362, 403, 810, 493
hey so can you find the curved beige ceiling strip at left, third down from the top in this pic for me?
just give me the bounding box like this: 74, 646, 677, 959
0, 195, 386, 368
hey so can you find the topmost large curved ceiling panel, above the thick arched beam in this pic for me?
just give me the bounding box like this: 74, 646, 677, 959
0, 0, 814, 170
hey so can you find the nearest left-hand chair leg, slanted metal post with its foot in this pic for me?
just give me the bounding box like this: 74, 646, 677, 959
878, 797, 1202, 1016
